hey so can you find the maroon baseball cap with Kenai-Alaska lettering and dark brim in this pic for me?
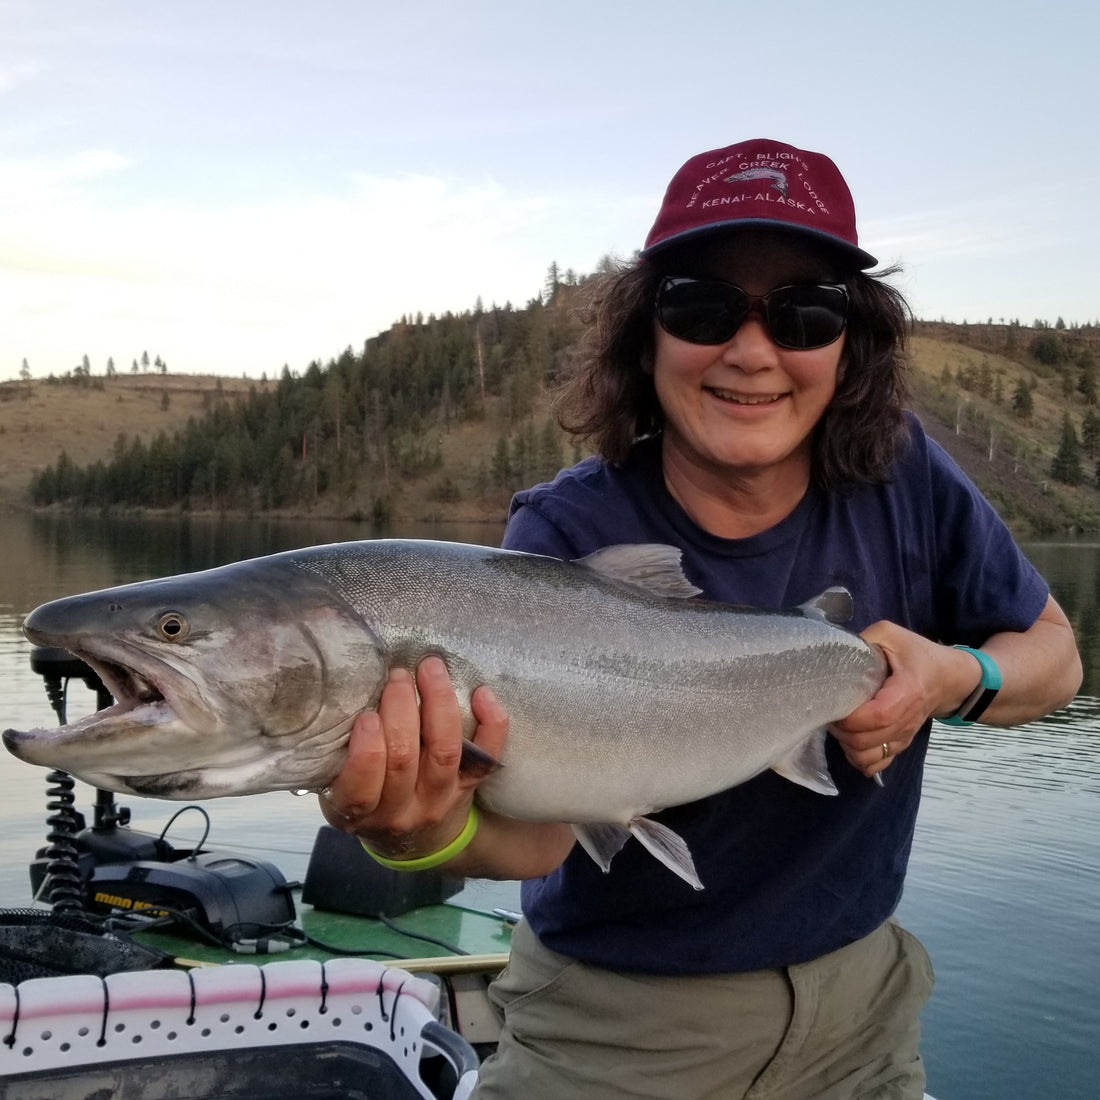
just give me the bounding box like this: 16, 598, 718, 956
641, 138, 878, 268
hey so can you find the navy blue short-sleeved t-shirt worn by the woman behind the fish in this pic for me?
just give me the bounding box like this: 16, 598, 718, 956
504, 418, 1047, 974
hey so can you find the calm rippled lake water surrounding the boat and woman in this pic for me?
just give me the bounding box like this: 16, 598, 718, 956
0, 514, 1100, 1100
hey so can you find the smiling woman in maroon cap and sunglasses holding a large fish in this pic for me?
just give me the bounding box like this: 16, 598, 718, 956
322, 141, 1081, 1100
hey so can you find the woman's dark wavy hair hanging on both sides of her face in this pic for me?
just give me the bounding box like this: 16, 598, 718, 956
554, 261, 912, 488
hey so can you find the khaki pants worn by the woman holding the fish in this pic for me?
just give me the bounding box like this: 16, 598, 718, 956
475, 921, 933, 1100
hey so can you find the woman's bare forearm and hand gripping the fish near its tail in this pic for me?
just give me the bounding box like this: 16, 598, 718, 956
832, 596, 1081, 776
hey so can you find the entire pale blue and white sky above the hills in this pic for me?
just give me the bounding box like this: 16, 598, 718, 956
0, 0, 1100, 380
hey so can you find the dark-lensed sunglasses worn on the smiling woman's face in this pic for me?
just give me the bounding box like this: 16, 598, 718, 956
657, 276, 848, 351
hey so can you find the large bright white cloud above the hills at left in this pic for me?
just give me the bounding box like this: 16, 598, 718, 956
0, 151, 580, 375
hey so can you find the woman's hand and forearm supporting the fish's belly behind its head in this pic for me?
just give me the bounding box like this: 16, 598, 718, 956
320, 657, 574, 879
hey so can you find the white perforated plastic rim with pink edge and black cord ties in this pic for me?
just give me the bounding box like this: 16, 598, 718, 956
0, 958, 477, 1100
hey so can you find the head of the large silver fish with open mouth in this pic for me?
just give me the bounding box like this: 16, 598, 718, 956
3, 559, 385, 799
